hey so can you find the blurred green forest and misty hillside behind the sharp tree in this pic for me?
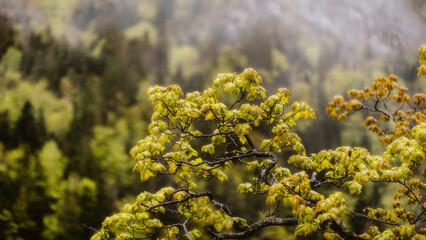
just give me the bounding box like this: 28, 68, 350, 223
0, 0, 426, 240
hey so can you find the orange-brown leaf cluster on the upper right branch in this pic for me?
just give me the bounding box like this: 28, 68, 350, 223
327, 62, 426, 145
